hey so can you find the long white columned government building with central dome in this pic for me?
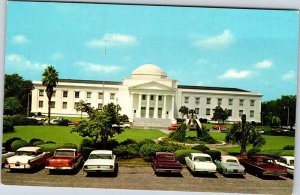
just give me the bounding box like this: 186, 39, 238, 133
31, 64, 262, 126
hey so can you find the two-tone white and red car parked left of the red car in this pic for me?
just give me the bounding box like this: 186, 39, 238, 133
5, 146, 50, 170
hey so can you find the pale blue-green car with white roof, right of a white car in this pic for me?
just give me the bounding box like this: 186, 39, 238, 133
215, 156, 245, 175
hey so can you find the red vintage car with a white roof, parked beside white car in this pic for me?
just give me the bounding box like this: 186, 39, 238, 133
46, 148, 83, 173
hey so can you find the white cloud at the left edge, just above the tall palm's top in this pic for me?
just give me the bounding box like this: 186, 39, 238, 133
5, 54, 47, 71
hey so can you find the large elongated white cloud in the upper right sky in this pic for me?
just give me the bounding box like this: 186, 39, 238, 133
193, 29, 235, 48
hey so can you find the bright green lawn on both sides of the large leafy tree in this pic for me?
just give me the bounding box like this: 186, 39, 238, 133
3, 125, 166, 145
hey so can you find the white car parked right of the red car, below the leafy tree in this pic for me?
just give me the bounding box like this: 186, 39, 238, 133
83, 150, 118, 174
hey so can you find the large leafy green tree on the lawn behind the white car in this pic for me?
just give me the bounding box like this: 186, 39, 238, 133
71, 103, 128, 149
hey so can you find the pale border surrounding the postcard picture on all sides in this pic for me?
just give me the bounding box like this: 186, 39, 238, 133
0, 0, 300, 195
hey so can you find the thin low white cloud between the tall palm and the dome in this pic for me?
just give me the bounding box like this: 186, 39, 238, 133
75, 61, 121, 73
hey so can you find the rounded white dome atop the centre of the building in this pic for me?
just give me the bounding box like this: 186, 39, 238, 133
131, 64, 168, 79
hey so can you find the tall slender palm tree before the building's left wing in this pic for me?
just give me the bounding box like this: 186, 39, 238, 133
42, 65, 58, 125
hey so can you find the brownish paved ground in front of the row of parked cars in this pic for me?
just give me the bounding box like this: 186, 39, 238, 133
2, 165, 293, 195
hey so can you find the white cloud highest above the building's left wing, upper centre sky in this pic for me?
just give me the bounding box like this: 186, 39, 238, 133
86, 33, 137, 48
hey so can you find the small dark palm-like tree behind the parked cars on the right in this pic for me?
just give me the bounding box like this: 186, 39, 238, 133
225, 114, 266, 154
